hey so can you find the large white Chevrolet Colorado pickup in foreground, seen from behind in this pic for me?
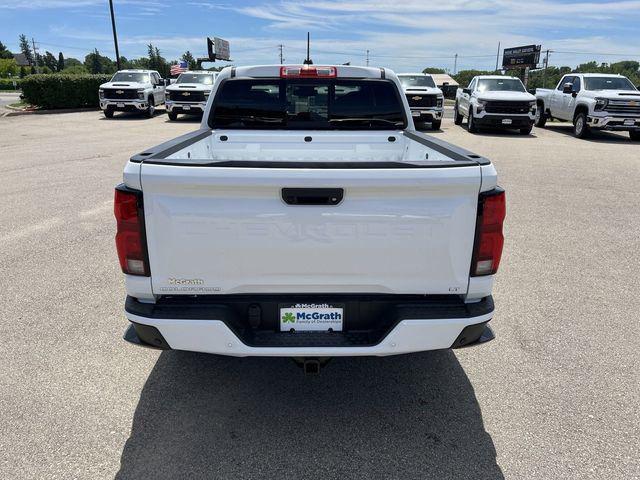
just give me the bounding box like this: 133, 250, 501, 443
115, 65, 505, 372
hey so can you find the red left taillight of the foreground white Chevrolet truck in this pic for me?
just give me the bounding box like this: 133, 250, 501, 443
113, 186, 149, 276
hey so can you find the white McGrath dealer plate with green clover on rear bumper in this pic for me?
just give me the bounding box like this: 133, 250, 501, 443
280, 303, 344, 332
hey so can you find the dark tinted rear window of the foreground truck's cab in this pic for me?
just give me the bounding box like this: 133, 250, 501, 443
209, 78, 407, 130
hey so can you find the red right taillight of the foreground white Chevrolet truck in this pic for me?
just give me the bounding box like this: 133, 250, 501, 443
471, 187, 506, 277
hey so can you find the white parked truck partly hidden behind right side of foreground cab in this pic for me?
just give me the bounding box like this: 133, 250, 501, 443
398, 73, 444, 130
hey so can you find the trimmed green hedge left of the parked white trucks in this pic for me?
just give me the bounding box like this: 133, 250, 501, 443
22, 73, 111, 109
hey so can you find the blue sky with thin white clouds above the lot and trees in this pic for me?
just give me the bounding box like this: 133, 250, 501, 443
0, 0, 640, 71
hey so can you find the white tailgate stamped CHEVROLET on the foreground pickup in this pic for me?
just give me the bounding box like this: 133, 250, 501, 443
141, 163, 481, 295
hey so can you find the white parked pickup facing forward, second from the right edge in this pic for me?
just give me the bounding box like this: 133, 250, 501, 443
453, 75, 536, 135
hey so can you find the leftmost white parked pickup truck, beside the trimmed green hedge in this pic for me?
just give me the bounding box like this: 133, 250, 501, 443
98, 70, 169, 118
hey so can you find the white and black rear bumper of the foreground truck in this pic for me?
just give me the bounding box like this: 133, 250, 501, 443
125, 295, 494, 357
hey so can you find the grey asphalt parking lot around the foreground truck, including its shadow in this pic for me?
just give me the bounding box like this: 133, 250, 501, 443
0, 112, 640, 480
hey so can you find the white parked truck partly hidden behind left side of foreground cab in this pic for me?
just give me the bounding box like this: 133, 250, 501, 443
165, 70, 218, 120
